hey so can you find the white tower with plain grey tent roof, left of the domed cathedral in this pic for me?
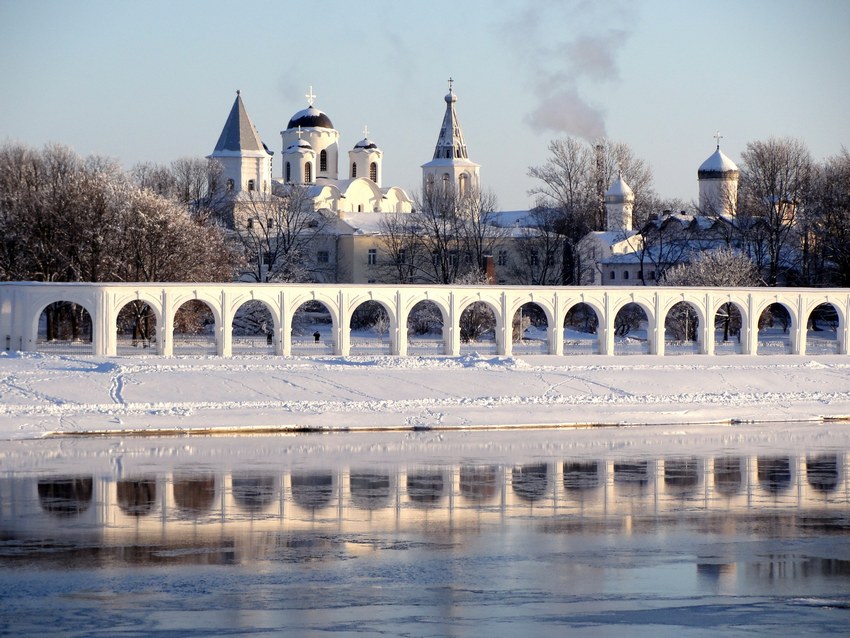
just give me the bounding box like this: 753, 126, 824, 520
207, 91, 272, 193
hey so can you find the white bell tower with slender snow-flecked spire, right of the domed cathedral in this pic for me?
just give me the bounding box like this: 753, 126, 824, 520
422, 78, 480, 193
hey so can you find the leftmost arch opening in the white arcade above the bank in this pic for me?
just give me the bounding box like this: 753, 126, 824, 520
33, 299, 94, 354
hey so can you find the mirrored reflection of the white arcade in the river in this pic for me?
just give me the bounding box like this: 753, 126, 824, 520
0, 453, 850, 554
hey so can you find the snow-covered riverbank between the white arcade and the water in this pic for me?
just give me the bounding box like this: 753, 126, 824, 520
0, 354, 850, 439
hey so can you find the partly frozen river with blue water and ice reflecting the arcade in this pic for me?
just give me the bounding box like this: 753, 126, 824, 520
0, 432, 850, 637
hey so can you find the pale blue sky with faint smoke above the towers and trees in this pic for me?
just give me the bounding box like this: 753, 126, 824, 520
0, 0, 850, 210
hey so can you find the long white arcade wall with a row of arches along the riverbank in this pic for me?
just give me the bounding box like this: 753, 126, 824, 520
0, 282, 850, 356
